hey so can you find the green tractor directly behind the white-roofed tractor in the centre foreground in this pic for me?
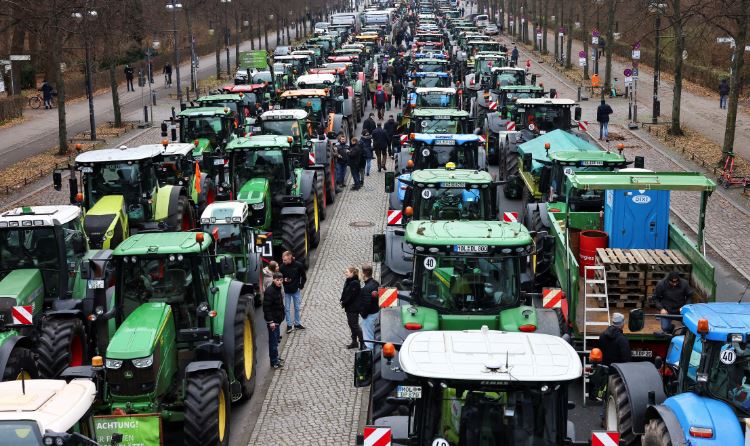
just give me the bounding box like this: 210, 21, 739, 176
371, 220, 564, 418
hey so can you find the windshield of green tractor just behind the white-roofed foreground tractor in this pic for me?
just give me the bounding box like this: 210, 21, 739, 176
415, 256, 520, 313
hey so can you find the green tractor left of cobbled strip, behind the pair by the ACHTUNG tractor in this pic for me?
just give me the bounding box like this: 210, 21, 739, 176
226, 135, 321, 266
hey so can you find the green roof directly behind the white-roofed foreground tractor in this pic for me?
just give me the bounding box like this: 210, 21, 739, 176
406, 220, 531, 246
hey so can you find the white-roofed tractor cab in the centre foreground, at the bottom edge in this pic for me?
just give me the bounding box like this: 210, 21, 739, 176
354, 326, 583, 446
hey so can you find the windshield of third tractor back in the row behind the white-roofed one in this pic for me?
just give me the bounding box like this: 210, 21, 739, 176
414, 187, 489, 220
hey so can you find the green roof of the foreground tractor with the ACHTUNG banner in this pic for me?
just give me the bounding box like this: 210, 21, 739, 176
112, 232, 211, 256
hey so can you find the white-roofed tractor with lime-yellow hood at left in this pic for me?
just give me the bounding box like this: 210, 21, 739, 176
53, 145, 195, 249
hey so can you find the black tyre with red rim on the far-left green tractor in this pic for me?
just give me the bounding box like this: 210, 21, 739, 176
37, 318, 88, 379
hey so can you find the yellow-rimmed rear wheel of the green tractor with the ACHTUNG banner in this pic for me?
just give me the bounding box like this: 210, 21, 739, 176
234, 294, 258, 400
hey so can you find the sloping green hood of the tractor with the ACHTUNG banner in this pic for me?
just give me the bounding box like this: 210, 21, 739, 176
107, 302, 172, 359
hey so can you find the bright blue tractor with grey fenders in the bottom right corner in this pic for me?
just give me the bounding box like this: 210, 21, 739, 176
604, 303, 750, 446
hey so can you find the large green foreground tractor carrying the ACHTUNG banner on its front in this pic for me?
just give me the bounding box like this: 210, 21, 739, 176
83, 232, 257, 446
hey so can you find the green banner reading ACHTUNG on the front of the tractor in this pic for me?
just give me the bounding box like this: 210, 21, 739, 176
94, 414, 163, 446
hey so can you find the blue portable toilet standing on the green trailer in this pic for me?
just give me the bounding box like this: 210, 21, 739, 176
604, 190, 669, 249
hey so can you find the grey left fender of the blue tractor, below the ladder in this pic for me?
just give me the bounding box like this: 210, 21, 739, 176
612, 362, 666, 434
